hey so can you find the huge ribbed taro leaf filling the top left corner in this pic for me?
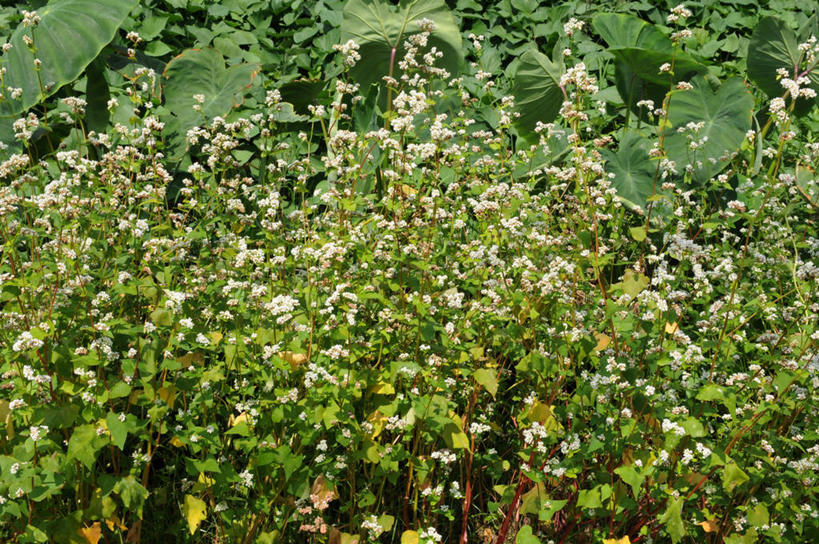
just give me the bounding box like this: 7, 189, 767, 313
0, 0, 136, 116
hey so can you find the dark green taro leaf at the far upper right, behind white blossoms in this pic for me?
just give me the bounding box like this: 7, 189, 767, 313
747, 17, 819, 114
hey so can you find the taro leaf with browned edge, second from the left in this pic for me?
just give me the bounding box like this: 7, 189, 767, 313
162, 48, 259, 159
